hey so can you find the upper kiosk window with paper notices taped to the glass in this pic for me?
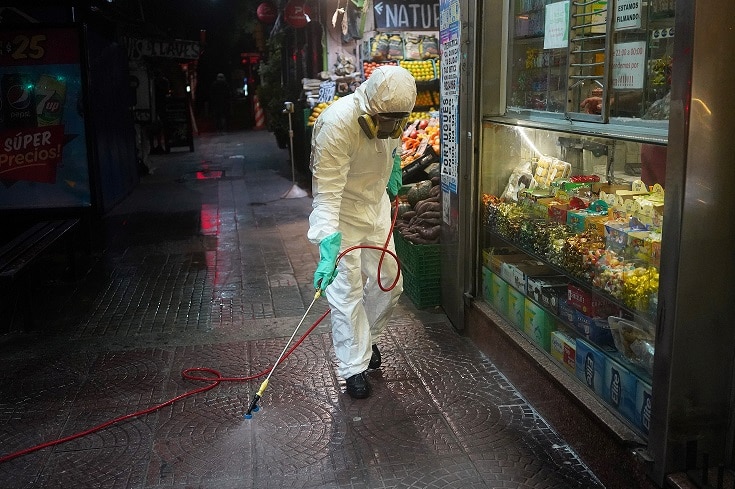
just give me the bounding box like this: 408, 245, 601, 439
507, 0, 674, 127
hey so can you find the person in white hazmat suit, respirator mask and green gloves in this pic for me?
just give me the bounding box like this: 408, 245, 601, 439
308, 66, 416, 399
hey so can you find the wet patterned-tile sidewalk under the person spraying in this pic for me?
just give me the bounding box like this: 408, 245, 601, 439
0, 132, 602, 489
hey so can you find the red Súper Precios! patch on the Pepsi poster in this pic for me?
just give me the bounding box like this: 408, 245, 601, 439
0, 124, 64, 183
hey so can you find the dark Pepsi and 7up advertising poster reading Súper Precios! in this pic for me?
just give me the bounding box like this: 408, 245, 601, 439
0, 27, 91, 209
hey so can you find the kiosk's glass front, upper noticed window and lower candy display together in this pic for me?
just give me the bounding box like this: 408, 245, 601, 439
476, 0, 674, 443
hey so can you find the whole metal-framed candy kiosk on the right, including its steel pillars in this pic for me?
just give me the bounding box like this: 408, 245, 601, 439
442, 0, 735, 487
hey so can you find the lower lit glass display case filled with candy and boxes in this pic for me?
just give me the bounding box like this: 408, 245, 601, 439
478, 121, 666, 437
